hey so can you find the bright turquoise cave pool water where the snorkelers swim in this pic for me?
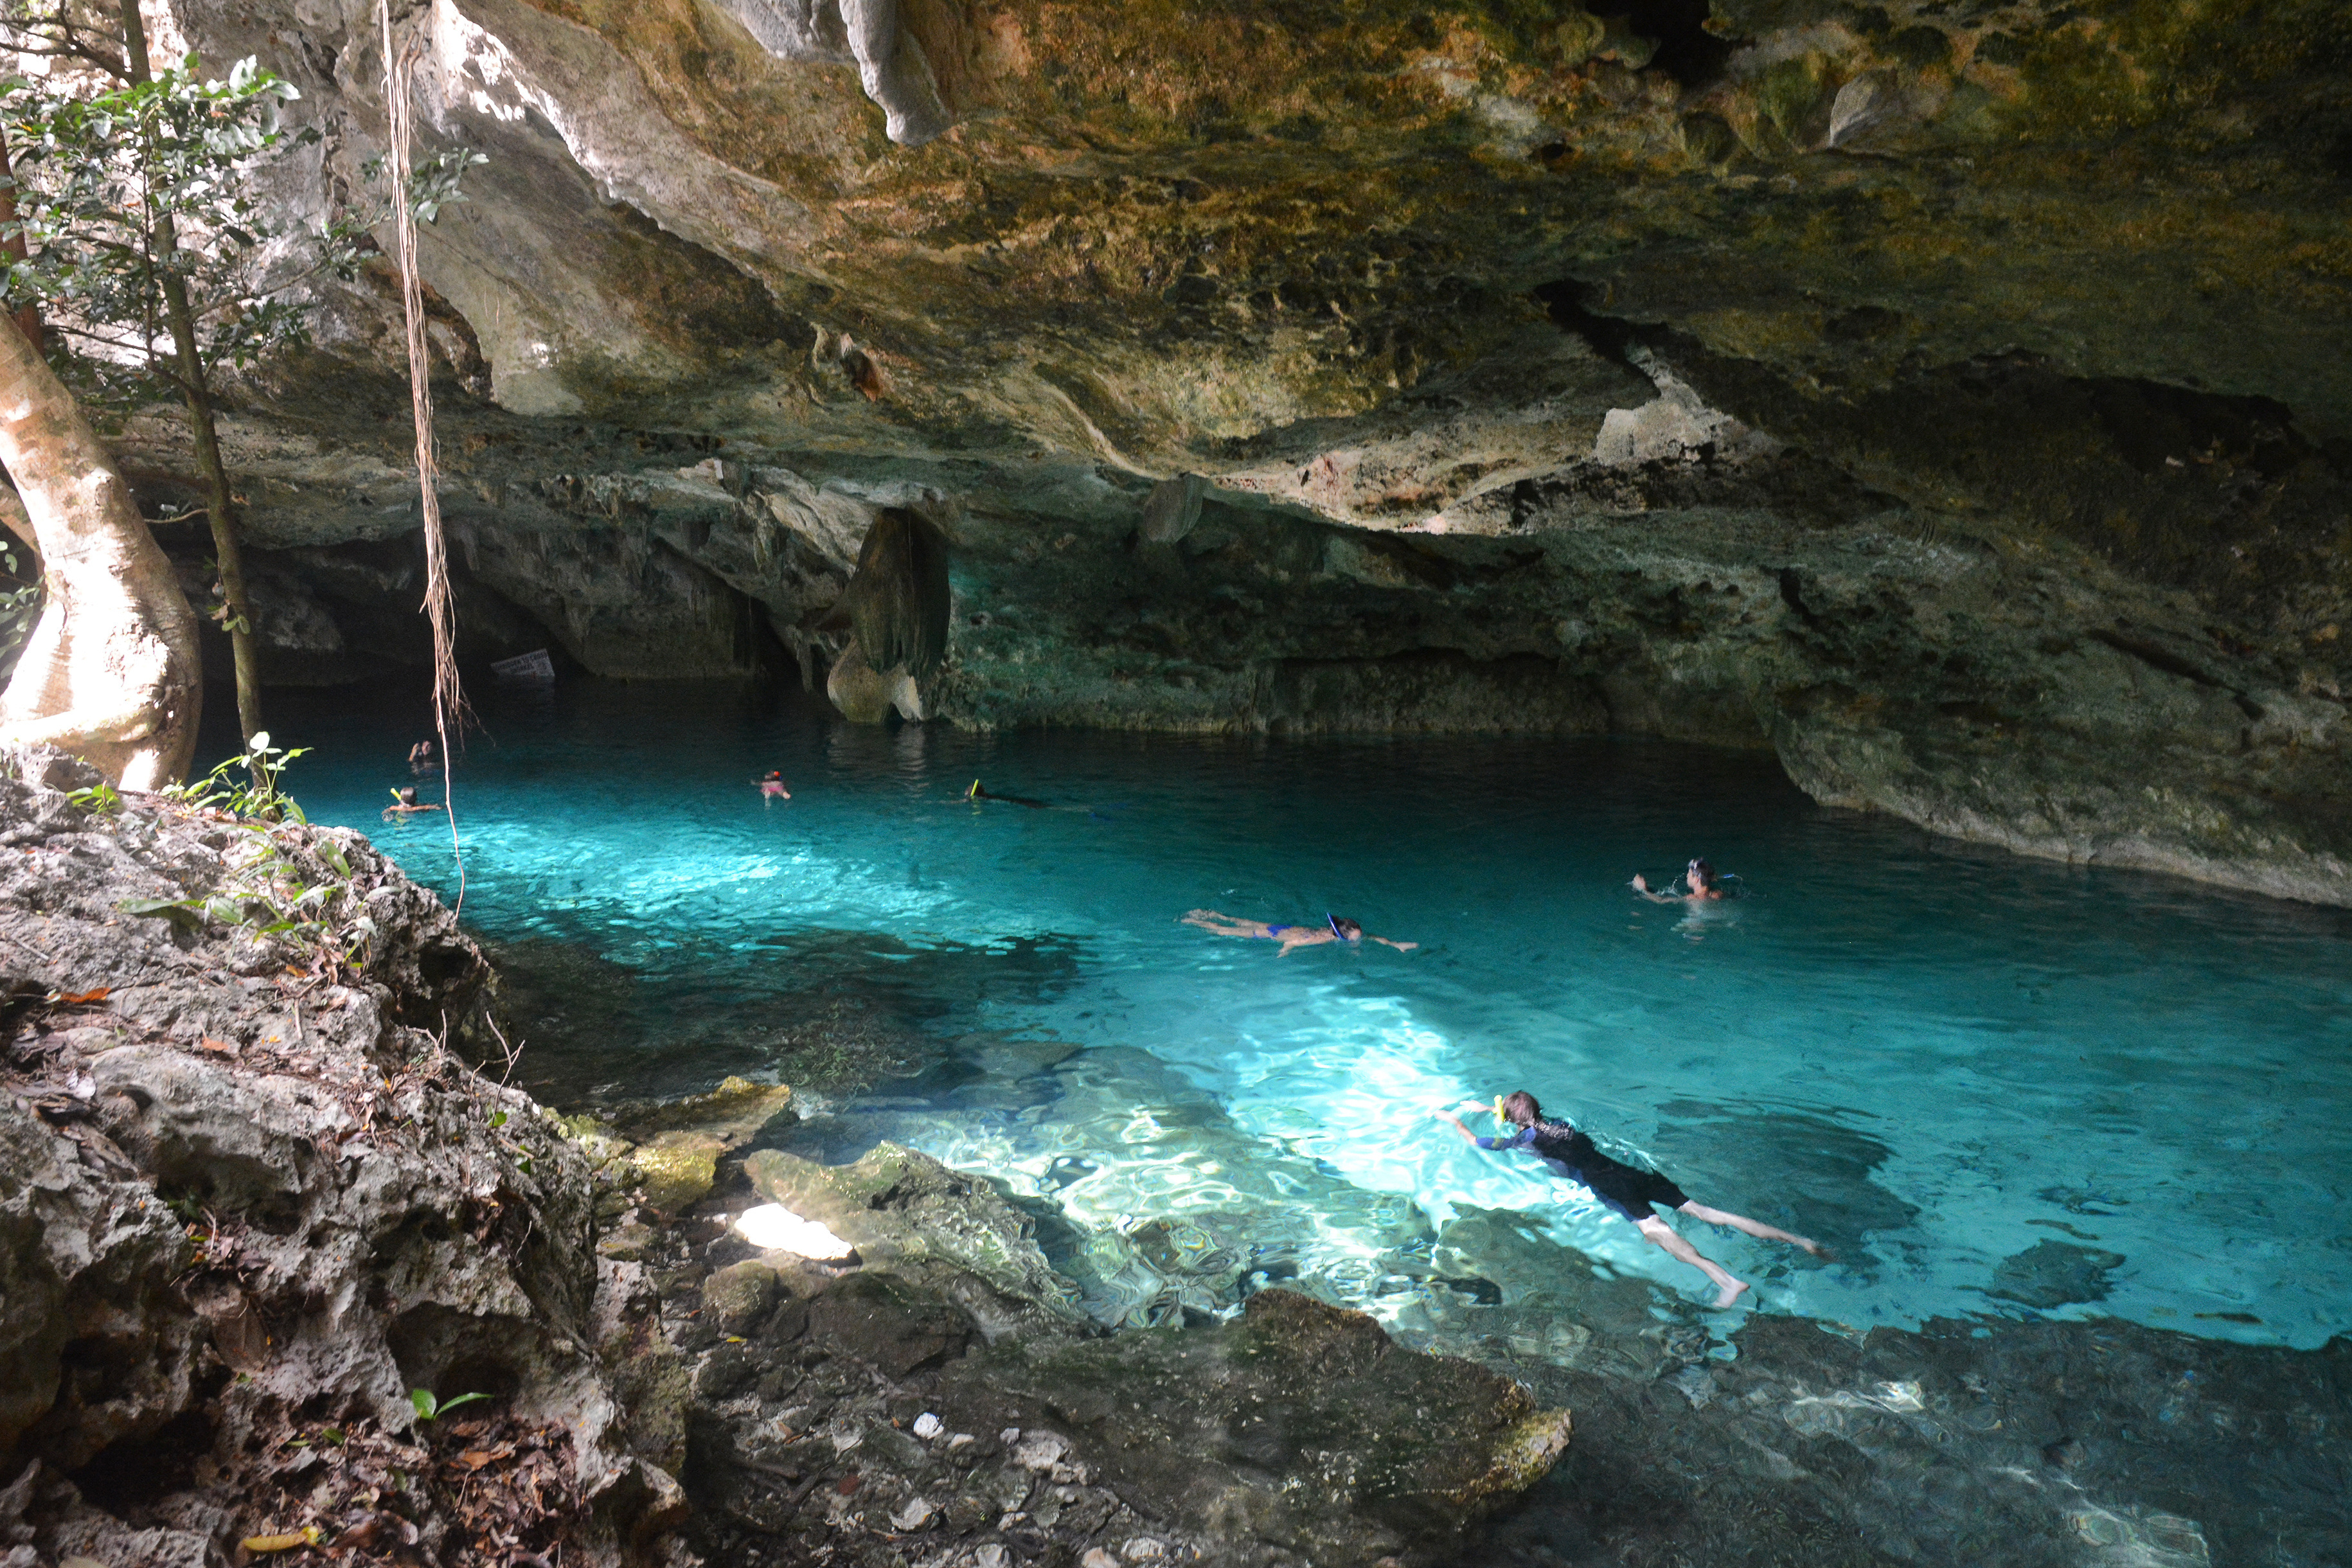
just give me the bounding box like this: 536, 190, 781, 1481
243, 684, 2352, 1347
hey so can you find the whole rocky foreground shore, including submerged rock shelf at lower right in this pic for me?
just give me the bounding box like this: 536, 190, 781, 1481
0, 753, 2352, 1568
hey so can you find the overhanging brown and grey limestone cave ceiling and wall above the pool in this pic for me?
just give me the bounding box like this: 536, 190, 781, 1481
142, 0, 2352, 903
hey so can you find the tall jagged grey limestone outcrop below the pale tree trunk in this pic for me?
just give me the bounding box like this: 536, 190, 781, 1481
0, 753, 677, 1564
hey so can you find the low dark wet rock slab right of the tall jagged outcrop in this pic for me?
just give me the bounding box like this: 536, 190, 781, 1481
647, 1145, 1569, 1565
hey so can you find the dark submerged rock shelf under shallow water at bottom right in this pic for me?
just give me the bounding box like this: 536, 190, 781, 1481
1397, 1215, 2352, 1568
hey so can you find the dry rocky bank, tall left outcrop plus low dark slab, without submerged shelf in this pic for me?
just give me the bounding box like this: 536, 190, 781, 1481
0, 753, 1569, 1568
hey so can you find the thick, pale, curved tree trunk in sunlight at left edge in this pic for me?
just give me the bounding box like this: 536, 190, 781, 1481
0, 320, 202, 790
